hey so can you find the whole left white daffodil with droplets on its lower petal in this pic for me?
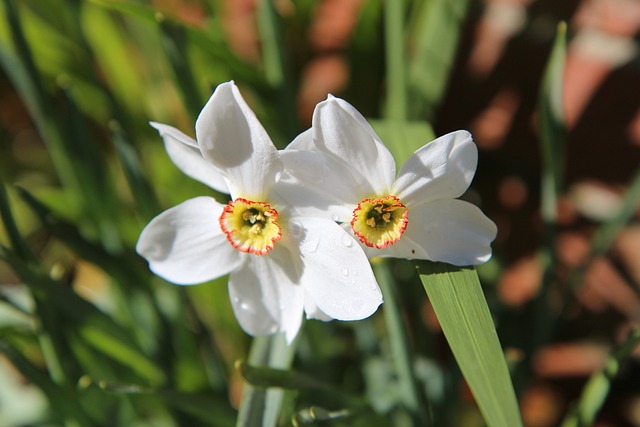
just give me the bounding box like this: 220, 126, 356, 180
136, 82, 382, 342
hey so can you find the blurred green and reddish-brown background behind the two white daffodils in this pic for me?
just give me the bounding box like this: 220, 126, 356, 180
0, 0, 640, 427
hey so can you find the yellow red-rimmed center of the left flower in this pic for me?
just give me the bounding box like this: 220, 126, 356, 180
220, 198, 282, 255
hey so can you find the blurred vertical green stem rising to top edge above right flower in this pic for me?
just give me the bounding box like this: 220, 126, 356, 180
384, 0, 407, 121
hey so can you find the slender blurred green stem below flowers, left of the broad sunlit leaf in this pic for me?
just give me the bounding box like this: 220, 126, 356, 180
373, 260, 430, 426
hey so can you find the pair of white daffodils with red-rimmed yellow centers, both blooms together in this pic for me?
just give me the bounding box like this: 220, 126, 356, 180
136, 82, 496, 342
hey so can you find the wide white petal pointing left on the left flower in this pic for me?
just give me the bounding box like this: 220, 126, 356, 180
136, 197, 242, 285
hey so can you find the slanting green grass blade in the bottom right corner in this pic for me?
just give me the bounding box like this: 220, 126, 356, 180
561, 329, 640, 427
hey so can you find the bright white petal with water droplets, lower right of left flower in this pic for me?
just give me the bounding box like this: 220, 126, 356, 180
290, 217, 382, 320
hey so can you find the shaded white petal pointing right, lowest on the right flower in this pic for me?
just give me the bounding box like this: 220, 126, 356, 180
379, 199, 497, 265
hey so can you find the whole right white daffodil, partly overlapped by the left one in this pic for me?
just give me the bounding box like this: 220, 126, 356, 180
282, 96, 497, 265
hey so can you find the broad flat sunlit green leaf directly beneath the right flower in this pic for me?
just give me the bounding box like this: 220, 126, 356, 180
416, 261, 522, 427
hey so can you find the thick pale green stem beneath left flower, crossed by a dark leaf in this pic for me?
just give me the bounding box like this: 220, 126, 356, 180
236, 334, 296, 427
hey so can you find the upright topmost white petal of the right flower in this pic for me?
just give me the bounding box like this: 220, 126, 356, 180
312, 96, 396, 196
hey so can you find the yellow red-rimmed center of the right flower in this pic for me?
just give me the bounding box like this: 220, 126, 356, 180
351, 196, 409, 249
